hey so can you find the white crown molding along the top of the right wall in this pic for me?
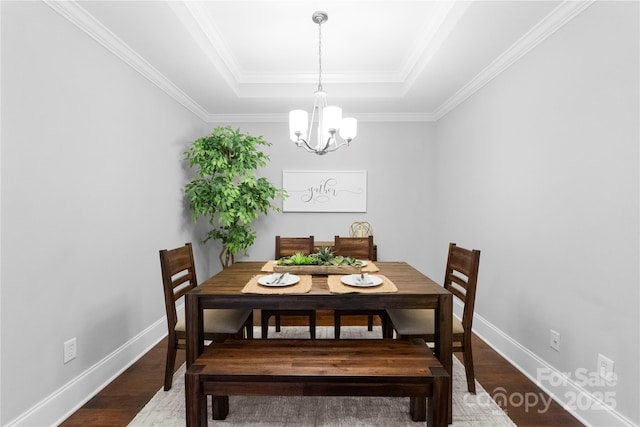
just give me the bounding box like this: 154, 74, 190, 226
433, 0, 595, 120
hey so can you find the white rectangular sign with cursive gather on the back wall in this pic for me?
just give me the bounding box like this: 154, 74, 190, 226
282, 170, 367, 212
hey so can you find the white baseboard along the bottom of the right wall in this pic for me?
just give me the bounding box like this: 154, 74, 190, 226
462, 301, 635, 427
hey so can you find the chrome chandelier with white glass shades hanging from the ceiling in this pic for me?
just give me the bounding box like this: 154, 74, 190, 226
289, 11, 358, 154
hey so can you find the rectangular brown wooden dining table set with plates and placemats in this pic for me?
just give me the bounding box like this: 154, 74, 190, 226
185, 262, 453, 422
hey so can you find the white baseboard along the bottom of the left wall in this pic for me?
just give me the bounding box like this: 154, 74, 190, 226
6, 317, 167, 427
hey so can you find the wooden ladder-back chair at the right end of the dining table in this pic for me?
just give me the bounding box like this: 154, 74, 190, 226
387, 243, 480, 394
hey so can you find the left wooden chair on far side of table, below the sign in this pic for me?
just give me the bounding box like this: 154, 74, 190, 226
261, 236, 316, 340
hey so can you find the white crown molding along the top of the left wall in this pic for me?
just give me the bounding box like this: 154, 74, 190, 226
43, 0, 212, 120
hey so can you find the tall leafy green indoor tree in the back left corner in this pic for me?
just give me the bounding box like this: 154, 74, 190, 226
184, 126, 285, 268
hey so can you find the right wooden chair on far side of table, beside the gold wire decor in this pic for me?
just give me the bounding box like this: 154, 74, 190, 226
333, 235, 386, 339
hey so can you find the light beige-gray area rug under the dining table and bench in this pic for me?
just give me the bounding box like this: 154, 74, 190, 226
129, 326, 515, 427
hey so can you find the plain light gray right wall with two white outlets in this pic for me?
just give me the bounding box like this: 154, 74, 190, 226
433, 2, 640, 425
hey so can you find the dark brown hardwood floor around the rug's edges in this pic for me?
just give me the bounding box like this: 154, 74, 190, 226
61, 313, 582, 427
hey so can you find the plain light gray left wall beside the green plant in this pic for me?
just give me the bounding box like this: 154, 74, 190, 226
0, 2, 205, 425
